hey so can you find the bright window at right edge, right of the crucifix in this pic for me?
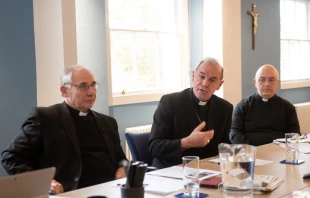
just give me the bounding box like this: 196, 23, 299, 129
280, 0, 310, 88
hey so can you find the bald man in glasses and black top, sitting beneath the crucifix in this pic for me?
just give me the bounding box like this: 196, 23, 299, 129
230, 64, 300, 146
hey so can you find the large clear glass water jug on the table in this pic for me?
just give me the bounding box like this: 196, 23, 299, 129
218, 143, 256, 198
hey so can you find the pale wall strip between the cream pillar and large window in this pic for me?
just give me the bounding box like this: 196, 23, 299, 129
76, 0, 109, 115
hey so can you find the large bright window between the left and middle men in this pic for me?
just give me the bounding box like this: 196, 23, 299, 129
107, 0, 190, 105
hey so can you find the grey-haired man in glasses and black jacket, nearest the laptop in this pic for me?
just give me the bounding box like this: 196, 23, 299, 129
1, 66, 126, 194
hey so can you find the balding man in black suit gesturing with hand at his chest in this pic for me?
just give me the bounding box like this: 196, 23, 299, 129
148, 58, 233, 168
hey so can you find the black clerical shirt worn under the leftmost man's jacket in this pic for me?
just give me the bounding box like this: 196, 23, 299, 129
69, 106, 116, 188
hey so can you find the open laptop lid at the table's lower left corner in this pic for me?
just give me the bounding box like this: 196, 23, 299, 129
0, 167, 56, 198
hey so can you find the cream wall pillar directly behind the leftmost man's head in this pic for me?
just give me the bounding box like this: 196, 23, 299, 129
33, 0, 77, 106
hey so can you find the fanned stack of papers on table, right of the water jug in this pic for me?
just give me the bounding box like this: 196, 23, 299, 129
253, 175, 284, 191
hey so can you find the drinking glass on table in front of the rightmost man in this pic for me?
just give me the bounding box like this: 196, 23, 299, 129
285, 133, 299, 163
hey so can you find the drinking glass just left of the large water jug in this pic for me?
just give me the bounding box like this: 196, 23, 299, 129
182, 156, 199, 197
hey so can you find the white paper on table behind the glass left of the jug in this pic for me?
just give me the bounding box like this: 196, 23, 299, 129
146, 166, 221, 181
